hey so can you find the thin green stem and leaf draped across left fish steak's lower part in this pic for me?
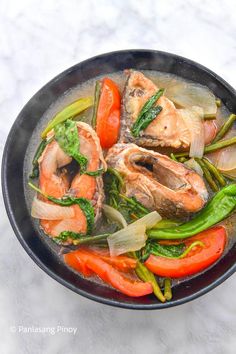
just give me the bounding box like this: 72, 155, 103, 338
28, 183, 94, 234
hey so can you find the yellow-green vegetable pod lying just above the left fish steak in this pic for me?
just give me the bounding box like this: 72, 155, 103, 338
41, 97, 93, 139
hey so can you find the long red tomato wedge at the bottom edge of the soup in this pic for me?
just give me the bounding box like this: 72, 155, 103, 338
65, 249, 153, 297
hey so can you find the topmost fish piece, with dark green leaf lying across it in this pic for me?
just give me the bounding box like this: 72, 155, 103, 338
119, 70, 191, 149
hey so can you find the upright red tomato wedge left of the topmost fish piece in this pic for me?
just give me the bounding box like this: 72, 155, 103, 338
96, 78, 121, 149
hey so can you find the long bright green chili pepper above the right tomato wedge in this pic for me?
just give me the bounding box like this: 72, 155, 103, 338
147, 184, 236, 240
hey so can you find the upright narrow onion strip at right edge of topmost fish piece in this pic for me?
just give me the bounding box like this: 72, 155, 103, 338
179, 106, 205, 158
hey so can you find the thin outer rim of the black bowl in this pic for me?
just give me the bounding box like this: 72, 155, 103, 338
1, 49, 236, 310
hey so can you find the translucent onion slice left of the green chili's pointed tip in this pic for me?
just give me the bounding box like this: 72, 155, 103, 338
107, 211, 161, 256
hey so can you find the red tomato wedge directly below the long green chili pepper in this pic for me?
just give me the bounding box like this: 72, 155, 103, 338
145, 226, 227, 278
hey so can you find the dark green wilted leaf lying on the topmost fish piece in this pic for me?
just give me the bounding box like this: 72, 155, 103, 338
131, 89, 164, 138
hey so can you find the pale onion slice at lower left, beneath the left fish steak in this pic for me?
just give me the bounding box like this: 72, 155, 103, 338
31, 197, 75, 220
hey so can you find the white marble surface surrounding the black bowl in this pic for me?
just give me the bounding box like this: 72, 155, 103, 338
0, 0, 236, 354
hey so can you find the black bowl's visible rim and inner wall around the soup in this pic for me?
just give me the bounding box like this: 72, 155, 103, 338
2, 50, 236, 309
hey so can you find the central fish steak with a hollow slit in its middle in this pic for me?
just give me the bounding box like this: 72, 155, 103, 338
106, 143, 208, 219
